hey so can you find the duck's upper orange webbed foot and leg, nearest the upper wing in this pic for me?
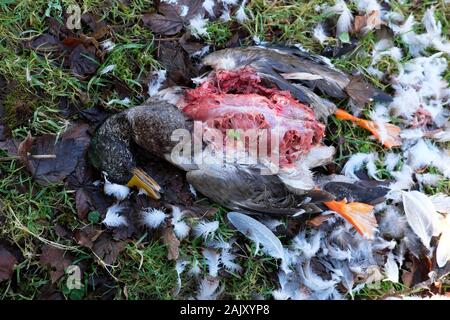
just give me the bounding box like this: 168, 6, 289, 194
335, 109, 402, 149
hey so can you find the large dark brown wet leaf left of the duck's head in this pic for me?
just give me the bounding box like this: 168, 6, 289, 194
18, 124, 90, 185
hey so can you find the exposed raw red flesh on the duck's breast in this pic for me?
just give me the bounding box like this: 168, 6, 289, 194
183, 67, 324, 165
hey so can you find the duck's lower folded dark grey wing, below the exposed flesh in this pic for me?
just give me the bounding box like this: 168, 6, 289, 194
187, 164, 334, 215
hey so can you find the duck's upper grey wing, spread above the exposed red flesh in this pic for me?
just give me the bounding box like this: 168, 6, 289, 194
203, 46, 390, 115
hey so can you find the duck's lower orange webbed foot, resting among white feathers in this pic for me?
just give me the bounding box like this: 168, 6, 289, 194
324, 199, 378, 240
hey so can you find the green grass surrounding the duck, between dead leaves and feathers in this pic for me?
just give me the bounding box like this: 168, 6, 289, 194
0, 0, 450, 299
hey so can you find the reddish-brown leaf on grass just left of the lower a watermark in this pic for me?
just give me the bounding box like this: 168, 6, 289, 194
39, 246, 73, 283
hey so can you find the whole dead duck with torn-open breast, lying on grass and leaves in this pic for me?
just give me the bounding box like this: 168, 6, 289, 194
90, 47, 398, 239
